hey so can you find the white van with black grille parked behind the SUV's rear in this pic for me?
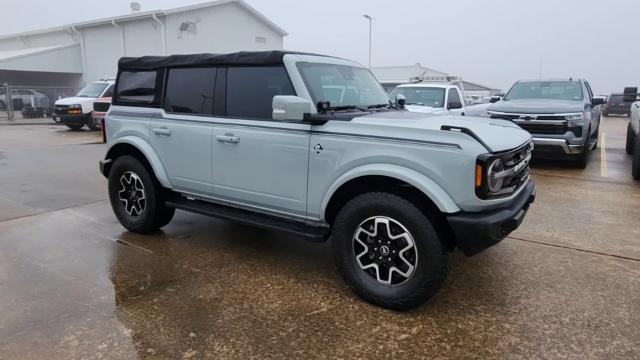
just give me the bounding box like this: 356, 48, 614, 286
53, 80, 115, 130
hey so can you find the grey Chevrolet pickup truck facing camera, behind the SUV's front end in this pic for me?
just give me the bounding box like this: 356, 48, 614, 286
487, 79, 604, 168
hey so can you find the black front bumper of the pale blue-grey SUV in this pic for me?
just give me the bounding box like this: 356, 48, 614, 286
447, 181, 536, 256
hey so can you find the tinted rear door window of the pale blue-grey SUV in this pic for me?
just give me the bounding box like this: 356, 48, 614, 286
164, 68, 216, 115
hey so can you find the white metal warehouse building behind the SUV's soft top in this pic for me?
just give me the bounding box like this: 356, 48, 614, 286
0, 0, 287, 88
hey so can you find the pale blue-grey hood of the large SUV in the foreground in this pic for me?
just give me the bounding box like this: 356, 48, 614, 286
351, 111, 531, 152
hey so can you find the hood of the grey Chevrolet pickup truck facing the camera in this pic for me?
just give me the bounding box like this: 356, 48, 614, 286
489, 100, 584, 114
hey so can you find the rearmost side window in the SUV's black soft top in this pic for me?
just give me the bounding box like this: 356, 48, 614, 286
116, 71, 160, 105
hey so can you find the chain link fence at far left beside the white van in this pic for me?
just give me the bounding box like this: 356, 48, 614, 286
0, 83, 78, 121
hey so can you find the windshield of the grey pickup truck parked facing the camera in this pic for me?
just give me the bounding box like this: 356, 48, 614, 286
505, 81, 583, 101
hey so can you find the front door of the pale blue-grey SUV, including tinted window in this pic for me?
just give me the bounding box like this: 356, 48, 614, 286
212, 66, 311, 216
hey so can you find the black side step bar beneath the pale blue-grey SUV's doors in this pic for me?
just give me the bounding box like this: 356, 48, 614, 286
165, 194, 330, 242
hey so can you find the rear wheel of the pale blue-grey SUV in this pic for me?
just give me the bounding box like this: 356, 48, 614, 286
109, 155, 175, 234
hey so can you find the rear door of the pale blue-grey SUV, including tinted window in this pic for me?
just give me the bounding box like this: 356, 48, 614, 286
149, 67, 216, 196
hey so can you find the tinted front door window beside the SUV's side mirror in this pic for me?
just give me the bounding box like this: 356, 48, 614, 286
226, 66, 295, 120
